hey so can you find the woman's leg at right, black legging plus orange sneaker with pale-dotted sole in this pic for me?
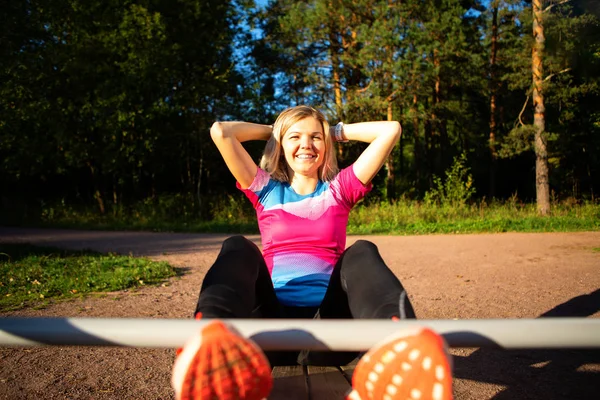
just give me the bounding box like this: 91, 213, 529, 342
328, 240, 452, 400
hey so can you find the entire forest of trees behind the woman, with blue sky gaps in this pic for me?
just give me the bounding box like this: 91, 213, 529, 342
0, 0, 600, 228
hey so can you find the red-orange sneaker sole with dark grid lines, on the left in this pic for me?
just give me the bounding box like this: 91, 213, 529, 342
171, 320, 273, 400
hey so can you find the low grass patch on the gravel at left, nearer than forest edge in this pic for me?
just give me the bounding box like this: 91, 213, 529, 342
0, 243, 176, 311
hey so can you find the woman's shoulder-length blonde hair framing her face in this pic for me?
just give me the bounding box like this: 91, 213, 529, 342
260, 106, 338, 183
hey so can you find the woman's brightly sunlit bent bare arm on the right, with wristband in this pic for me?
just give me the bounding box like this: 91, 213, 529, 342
332, 121, 402, 185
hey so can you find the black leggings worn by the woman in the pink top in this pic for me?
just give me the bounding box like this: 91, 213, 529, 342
196, 236, 416, 365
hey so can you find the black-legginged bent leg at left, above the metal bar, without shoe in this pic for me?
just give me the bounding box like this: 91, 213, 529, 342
195, 236, 281, 318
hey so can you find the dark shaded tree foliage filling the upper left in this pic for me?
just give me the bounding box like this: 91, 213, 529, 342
0, 0, 247, 213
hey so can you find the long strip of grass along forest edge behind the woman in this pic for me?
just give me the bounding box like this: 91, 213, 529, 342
9, 194, 600, 235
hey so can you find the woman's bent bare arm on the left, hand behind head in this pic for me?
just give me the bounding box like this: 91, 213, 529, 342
210, 122, 273, 189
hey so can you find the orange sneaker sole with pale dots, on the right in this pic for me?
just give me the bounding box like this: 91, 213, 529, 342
346, 328, 452, 400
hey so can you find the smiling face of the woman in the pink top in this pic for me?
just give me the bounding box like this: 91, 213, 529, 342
281, 117, 325, 178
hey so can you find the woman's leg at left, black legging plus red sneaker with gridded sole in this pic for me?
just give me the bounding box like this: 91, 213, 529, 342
171, 236, 281, 400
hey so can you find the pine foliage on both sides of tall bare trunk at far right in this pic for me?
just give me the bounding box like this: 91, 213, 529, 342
500, 0, 600, 197
